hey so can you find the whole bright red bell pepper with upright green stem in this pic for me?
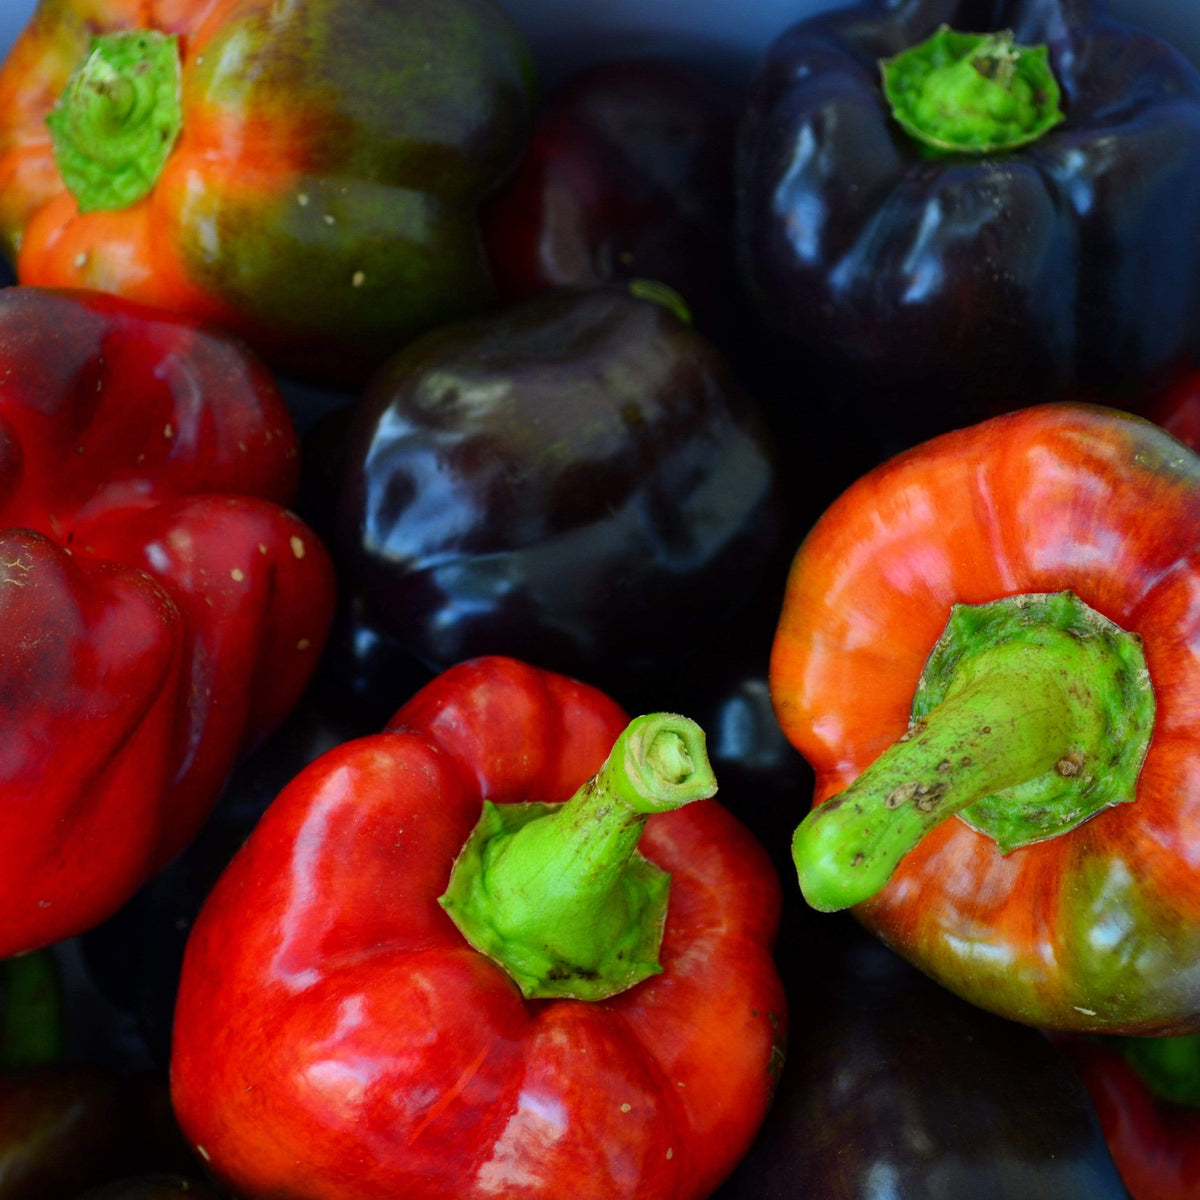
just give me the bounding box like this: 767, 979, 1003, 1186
172, 656, 786, 1200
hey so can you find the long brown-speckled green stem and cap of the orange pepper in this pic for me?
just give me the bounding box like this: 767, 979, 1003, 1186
792, 592, 1154, 912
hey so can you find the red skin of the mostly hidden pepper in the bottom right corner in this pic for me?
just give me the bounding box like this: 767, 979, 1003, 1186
1063, 1038, 1200, 1200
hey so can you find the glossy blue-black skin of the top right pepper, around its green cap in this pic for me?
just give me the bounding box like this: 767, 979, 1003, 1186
738, 0, 1200, 448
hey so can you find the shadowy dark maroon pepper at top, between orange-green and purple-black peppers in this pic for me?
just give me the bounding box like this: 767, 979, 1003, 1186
480, 58, 745, 350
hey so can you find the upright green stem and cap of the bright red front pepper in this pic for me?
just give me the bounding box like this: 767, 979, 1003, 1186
439, 713, 716, 1000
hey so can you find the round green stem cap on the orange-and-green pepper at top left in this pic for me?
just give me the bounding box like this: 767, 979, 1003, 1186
46, 29, 182, 212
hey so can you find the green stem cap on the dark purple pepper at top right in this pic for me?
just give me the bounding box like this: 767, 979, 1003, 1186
880, 25, 1063, 155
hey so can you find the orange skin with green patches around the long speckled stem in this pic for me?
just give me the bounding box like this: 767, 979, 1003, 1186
770, 404, 1200, 1033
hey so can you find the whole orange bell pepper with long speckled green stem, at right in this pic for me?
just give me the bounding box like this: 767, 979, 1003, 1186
770, 404, 1200, 1033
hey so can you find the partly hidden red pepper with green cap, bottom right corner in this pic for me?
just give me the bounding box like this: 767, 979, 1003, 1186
1063, 1034, 1200, 1200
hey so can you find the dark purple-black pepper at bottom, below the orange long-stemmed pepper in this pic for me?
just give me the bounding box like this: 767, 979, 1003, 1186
713, 912, 1128, 1200
